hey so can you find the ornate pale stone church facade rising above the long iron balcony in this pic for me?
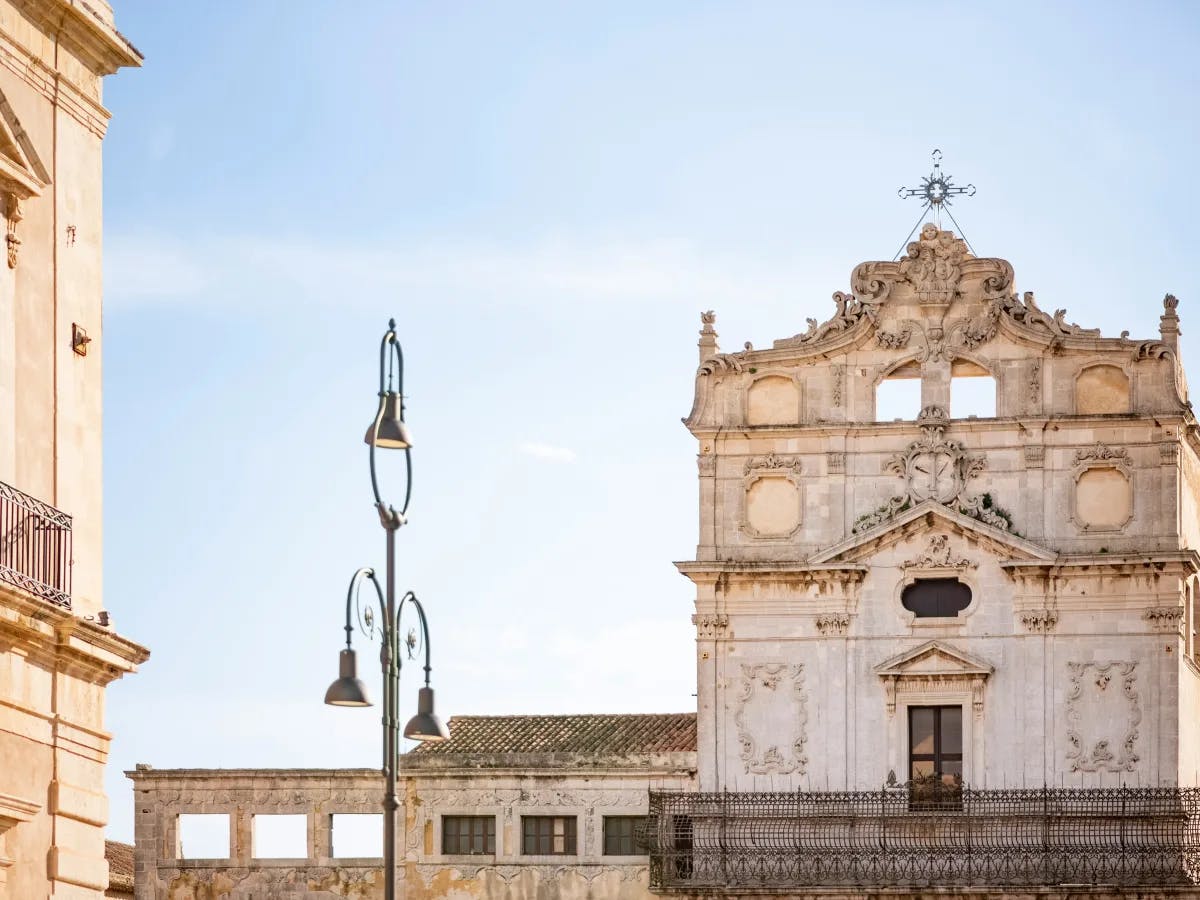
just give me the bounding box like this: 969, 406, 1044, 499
678, 224, 1200, 791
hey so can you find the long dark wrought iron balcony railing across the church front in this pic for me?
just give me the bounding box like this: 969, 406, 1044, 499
646, 785, 1200, 894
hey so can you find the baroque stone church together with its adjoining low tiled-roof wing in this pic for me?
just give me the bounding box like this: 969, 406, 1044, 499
130, 224, 1200, 900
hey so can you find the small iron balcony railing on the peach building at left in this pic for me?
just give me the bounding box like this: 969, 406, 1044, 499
0, 481, 71, 610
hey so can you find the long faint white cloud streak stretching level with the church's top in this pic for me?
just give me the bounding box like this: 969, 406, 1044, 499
104, 233, 803, 311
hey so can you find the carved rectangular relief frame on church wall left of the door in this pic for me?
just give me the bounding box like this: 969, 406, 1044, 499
733, 662, 809, 775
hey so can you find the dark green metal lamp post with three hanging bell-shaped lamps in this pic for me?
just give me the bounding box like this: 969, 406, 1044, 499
325, 319, 450, 900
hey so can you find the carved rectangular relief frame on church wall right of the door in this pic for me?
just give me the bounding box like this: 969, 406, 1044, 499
1067, 660, 1141, 772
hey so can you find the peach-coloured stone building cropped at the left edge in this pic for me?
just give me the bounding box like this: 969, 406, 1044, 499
0, 0, 148, 900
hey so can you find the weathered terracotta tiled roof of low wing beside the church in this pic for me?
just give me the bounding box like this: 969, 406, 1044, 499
410, 713, 696, 756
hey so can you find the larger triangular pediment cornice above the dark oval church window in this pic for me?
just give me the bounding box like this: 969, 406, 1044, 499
808, 500, 1057, 564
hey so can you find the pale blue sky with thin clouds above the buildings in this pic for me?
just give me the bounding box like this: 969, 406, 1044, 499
104, 0, 1200, 839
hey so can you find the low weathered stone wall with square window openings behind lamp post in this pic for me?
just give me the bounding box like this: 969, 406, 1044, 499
127, 754, 695, 900
